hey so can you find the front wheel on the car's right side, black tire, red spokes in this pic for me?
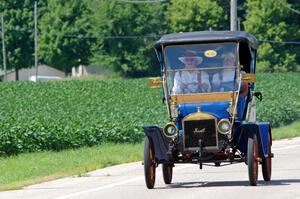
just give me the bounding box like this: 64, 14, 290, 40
247, 135, 258, 186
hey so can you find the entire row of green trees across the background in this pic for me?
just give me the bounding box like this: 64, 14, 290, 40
0, 0, 300, 77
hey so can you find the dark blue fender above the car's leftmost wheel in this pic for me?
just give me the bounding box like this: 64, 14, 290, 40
143, 126, 170, 163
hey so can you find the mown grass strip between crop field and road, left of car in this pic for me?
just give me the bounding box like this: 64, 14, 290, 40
0, 144, 143, 190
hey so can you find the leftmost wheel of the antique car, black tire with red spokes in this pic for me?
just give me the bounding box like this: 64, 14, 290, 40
144, 136, 156, 189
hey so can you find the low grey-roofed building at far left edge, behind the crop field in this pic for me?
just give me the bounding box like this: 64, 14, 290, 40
0, 65, 65, 82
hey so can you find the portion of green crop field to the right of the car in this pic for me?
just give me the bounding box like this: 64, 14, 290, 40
256, 73, 300, 127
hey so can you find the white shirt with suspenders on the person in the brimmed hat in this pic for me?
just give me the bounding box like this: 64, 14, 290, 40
172, 71, 211, 94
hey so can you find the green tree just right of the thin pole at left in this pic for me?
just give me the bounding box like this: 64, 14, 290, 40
39, 0, 91, 73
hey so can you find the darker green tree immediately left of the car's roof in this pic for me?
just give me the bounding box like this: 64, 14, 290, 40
91, 0, 165, 76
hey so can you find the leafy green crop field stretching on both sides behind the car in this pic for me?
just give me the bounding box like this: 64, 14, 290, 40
0, 73, 300, 155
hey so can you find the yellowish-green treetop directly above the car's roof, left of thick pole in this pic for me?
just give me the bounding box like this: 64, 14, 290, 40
166, 0, 227, 32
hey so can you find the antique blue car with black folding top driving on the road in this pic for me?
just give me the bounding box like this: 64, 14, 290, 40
143, 31, 273, 189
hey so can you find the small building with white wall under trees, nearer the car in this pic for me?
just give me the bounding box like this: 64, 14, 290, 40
72, 65, 105, 77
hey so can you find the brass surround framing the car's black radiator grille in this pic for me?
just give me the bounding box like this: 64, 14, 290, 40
182, 112, 219, 151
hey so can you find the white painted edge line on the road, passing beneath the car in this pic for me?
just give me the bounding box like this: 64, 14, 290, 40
53, 165, 194, 199
